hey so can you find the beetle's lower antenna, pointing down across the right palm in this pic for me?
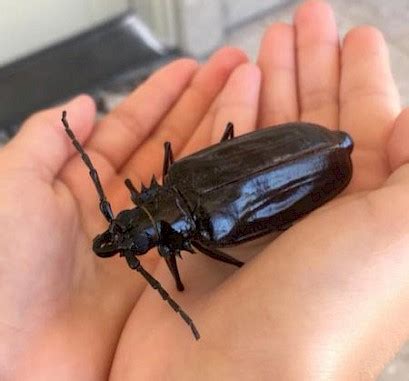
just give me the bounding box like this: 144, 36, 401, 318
125, 252, 200, 340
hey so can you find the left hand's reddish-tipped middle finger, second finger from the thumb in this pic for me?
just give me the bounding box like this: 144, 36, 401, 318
123, 48, 247, 181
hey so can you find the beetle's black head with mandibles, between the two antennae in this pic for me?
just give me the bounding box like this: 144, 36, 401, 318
92, 209, 155, 258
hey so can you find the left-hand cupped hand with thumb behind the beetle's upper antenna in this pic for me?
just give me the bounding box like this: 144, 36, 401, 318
0, 43, 255, 380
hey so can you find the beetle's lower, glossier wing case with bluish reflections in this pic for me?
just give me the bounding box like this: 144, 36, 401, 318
201, 141, 351, 247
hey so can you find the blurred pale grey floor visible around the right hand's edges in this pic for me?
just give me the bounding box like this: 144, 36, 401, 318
226, 0, 409, 381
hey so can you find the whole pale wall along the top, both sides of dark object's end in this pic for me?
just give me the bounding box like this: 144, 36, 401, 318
0, 0, 288, 66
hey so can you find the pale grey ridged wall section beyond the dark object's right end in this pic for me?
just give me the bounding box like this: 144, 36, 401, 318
130, 0, 289, 57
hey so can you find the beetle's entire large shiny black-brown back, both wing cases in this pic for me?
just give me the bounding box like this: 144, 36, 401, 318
167, 123, 352, 247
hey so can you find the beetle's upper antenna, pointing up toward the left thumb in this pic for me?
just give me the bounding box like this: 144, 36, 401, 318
61, 111, 114, 222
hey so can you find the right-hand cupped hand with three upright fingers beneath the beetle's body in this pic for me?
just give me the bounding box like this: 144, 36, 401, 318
111, 1, 409, 380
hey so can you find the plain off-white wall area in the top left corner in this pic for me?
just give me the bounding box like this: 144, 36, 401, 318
0, 0, 128, 65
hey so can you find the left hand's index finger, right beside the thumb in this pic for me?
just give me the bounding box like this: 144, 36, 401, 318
88, 59, 197, 170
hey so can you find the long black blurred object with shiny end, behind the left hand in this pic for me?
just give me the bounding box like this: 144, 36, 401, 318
0, 13, 179, 139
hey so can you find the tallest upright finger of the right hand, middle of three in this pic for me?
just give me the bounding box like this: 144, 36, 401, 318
294, 0, 340, 129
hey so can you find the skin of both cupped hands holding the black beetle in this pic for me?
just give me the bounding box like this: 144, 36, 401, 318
0, 1, 409, 381
